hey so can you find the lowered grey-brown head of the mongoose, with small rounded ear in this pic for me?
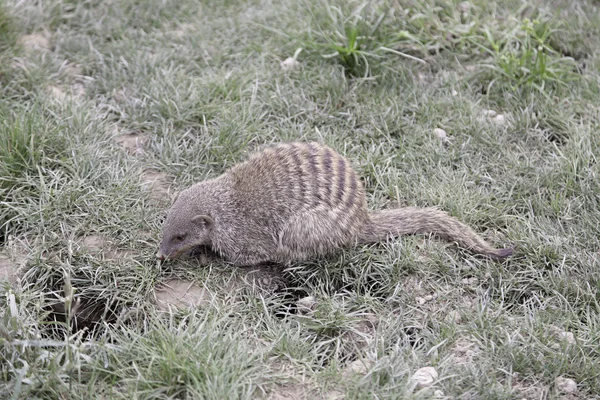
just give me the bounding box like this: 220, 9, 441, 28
156, 191, 214, 260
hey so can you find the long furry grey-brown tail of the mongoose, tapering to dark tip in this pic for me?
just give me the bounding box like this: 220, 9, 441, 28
359, 207, 513, 258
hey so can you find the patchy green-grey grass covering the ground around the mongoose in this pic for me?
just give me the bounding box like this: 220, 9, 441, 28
0, 0, 600, 399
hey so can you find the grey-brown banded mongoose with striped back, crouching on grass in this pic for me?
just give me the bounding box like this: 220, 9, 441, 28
156, 143, 513, 266
